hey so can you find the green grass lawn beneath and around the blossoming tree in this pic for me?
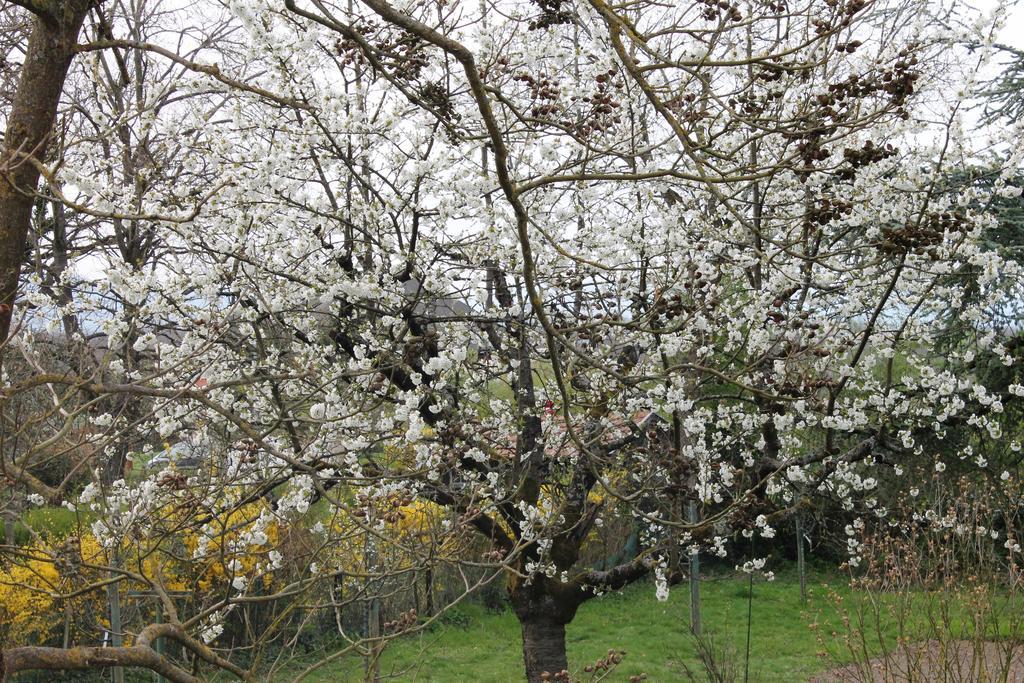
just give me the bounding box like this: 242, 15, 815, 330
278, 571, 1024, 683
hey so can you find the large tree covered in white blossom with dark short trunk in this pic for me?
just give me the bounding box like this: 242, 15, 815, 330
5, 0, 1024, 681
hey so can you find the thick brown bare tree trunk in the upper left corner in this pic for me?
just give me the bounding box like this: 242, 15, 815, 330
0, 0, 90, 358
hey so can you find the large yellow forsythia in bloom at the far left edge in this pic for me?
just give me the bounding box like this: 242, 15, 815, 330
0, 503, 287, 646
